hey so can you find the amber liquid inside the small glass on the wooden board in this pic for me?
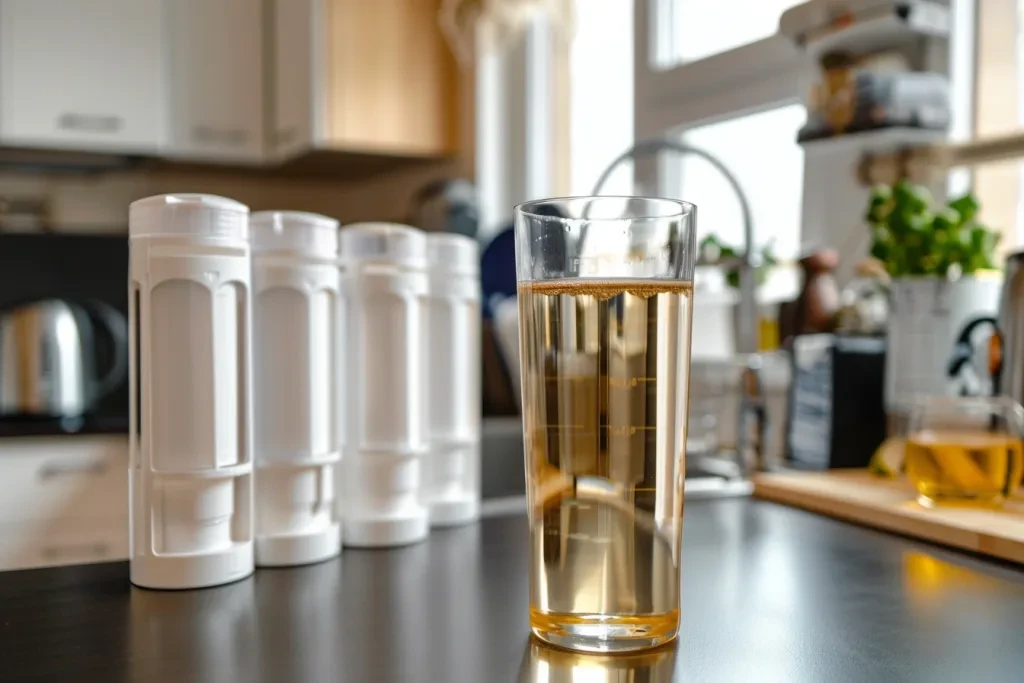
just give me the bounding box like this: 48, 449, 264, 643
906, 429, 1024, 506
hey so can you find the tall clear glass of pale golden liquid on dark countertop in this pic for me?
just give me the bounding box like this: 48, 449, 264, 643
515, 197, 696, 652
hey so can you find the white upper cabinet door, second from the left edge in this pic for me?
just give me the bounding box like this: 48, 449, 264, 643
167, 0, 264, 163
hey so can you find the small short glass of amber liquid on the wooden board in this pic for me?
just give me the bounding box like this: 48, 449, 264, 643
905, 397, 1024, 507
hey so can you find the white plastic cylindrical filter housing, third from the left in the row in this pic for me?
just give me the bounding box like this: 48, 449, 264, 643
341, 223, 429, 547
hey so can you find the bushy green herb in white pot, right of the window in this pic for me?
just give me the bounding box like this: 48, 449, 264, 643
864, 180, 1001, 413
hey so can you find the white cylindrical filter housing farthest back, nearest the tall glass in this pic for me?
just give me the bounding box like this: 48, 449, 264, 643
423, 233, 481, 526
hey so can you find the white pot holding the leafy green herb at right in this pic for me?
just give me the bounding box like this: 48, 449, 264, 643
886, 272, 1002, 415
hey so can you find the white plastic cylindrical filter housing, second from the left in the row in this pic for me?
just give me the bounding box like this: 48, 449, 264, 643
249, 211, 341, 566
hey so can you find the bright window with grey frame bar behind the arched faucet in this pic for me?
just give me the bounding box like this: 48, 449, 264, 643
634, 0, 811, 278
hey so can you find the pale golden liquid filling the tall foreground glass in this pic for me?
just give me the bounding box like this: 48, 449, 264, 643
519, 280, 692, 651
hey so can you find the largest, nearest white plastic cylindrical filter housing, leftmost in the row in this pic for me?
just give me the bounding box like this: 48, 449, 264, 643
128, 195, 253, 588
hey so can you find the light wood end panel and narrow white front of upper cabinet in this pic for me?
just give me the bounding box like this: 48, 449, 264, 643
270, 0, 460, 159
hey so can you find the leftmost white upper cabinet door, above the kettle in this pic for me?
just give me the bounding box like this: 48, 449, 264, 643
0, 0, 165, 154
